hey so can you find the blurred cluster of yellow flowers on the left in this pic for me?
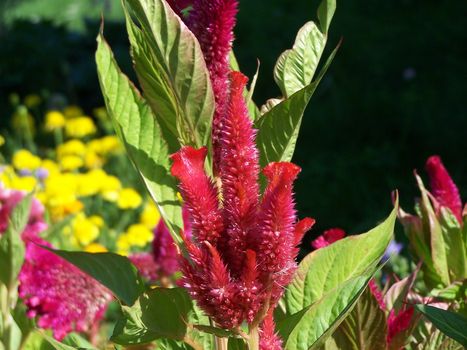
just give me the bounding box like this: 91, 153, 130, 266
0, 98, 160, 255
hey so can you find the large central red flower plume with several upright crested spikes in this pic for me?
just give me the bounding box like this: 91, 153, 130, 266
172, 72, 314, 329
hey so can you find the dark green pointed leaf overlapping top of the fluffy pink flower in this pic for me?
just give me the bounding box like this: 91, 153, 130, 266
42, 246, 145, 305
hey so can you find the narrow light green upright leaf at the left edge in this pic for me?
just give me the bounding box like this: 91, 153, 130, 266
0, 194, 32, 289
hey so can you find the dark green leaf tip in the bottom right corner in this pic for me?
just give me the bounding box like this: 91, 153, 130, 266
415, 304, 467, 346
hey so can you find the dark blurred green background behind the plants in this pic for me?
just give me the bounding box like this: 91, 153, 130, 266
0, 0, 467, 246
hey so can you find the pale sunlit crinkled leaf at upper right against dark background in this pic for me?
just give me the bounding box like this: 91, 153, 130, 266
274, 21, 326, 98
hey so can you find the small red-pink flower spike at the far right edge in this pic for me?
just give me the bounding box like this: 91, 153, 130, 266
425, 156, 462, 223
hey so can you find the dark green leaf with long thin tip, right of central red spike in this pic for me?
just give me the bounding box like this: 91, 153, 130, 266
255, 46, 339, 167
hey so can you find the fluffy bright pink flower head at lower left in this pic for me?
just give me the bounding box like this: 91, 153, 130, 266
19, 239, 111, 340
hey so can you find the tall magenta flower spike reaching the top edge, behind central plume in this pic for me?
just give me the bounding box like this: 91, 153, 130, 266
188, 0, 238, 174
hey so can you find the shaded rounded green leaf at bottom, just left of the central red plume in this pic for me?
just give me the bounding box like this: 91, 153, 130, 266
111, 288, 193, 345
